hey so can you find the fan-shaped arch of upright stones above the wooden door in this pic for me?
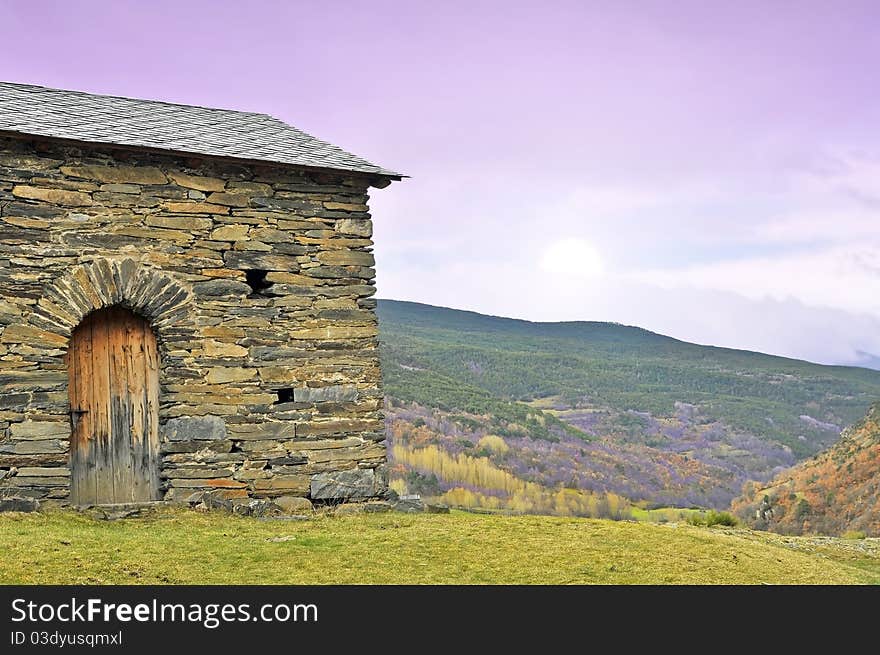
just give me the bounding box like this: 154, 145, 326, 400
28, 258, 192, 340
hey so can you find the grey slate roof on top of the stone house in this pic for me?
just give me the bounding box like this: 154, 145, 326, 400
0, 82, 402, 179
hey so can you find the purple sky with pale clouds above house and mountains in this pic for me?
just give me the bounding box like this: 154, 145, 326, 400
6, 0, 880, 362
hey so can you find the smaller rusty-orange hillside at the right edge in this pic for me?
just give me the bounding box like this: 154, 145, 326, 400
733, 403, 880, 536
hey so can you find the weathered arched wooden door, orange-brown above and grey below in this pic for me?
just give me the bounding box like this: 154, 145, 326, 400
67, 307, 159, 505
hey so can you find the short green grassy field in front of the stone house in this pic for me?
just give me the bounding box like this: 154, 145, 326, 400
0, 509, 880, 584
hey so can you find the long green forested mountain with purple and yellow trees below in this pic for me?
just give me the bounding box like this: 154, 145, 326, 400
378, 300, 880, 514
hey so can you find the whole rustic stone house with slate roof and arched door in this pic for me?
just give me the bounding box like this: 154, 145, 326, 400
0, 83, 402, 505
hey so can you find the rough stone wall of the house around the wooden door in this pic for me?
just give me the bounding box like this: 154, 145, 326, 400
0, 137, 386, 503
